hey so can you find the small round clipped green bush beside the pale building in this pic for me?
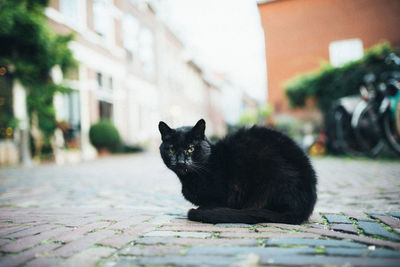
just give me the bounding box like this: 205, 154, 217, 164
89, 120, 121, 151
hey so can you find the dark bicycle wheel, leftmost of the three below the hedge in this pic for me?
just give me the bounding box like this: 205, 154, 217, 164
334, 107, 361, 156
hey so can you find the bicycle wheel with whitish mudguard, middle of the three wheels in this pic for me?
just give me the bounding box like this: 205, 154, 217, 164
351, 102, 385, 157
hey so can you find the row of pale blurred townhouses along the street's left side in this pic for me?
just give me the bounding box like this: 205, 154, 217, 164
0, 0, 236, 164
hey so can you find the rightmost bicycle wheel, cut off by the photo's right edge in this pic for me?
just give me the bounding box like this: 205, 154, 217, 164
382, 98, 400, 155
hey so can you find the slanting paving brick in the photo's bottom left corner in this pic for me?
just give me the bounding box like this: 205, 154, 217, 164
0, 243, 61, 267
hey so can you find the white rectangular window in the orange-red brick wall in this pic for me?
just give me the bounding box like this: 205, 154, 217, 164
329, 39, 364, 66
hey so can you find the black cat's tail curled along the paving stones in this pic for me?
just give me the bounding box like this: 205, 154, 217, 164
188, 208, 309, 224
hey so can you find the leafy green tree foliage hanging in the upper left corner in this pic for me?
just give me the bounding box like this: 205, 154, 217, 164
0, 0, 76, 144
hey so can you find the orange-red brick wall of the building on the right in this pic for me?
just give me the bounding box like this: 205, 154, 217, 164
258, 0, 400, 112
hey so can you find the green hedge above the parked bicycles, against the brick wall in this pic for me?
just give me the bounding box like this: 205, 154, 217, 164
284, 42, 398, 113
